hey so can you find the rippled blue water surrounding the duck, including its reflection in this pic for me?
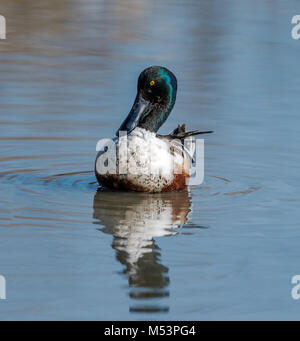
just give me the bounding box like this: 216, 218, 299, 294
0, 0, 300, 320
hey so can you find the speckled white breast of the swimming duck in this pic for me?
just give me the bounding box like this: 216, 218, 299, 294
96, 128, 191, 192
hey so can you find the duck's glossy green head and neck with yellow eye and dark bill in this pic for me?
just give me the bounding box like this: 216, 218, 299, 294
117, 66, 177, 135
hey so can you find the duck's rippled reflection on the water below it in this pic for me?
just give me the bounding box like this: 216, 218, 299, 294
94, 191, 191, 312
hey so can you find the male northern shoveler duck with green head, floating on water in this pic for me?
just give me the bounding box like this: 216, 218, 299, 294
95, 66, 211, 192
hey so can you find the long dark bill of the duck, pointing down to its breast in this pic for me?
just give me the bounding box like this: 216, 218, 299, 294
116, 94, 151, 136
